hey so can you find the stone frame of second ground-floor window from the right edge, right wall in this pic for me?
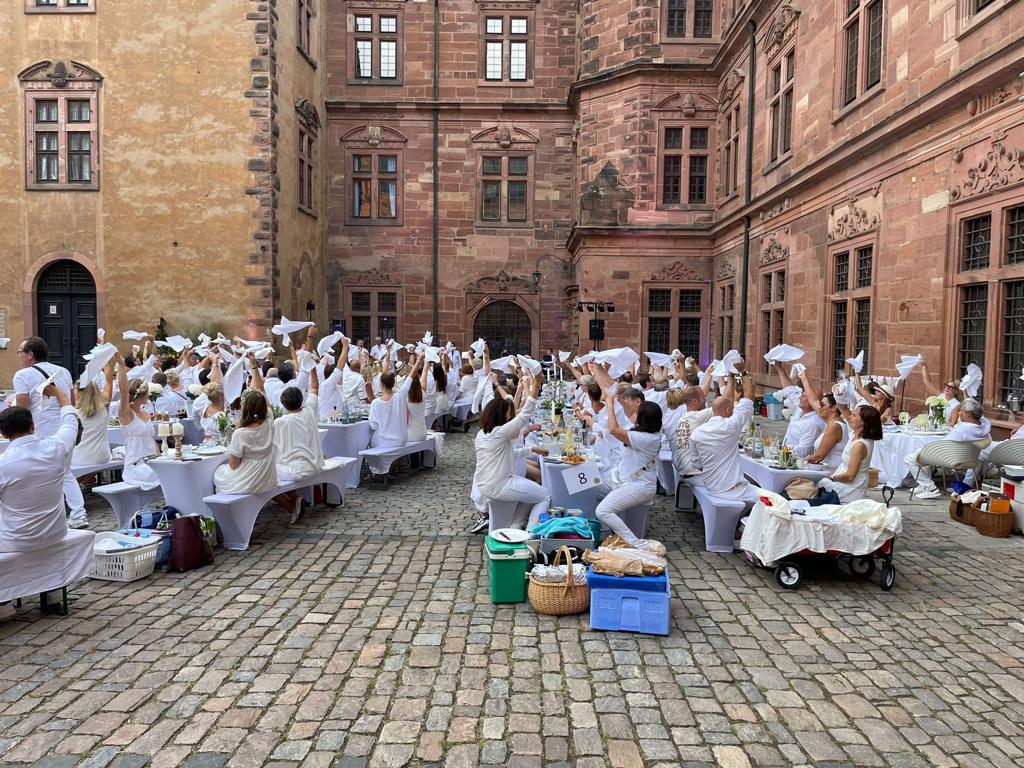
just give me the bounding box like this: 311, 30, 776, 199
821, 230, 879, 380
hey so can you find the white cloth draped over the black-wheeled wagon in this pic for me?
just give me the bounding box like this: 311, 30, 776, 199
739, 489, 903, 565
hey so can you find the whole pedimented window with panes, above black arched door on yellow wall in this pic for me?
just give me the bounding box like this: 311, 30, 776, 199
18, 61, 102, 190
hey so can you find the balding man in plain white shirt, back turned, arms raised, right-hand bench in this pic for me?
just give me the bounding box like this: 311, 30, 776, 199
690, 372, 757, 505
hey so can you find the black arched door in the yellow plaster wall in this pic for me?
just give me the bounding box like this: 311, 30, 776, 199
36, 259, 96, 377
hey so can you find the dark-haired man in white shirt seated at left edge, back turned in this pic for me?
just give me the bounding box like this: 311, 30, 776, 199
0, 384, 78, 552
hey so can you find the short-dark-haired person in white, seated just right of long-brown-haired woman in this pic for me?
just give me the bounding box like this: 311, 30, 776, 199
273, 368, 325, 523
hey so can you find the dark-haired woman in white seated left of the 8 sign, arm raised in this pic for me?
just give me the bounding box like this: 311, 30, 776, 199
473, 376, 551, 528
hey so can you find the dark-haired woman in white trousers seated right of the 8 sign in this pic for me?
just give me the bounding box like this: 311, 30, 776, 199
597, 392, 662, 549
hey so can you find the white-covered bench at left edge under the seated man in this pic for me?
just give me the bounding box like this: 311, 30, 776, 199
0, 530, 96, 615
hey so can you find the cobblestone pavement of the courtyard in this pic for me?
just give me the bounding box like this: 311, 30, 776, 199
0, 434, 1024, 768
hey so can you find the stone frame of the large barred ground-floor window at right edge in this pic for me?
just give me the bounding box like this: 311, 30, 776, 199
945, 188, 1024, 406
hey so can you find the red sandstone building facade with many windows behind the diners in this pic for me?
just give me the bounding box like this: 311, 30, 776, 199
326, 0, 1024, 430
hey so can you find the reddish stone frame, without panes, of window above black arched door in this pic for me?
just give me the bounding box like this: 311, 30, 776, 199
18, 61, 102, 191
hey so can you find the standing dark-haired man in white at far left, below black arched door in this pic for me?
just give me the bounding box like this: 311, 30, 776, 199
14, 336, 89, 528
